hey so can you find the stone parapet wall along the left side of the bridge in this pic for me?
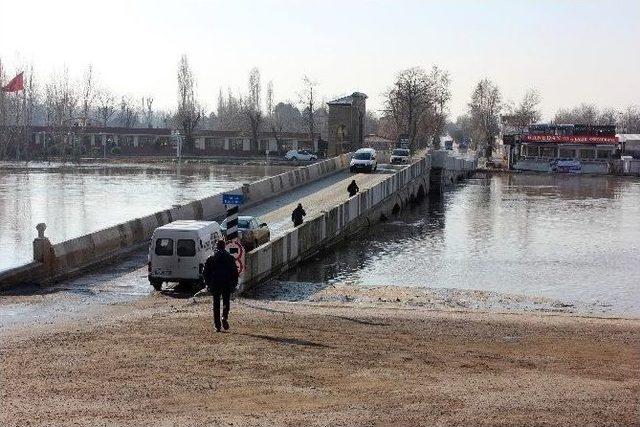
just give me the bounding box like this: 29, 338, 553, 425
0, 154, 351, 289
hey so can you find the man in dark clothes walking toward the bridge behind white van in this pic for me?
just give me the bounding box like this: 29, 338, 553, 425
203, 240, 238, 332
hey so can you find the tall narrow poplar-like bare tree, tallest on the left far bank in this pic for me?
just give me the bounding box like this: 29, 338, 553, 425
175, 55, 203, 151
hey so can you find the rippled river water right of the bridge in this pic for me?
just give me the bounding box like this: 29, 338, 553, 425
281, 174, 640, 315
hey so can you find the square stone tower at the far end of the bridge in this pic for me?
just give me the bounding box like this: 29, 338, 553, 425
327, 92, 367, 157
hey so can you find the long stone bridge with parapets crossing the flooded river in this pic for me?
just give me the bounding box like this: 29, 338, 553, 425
0, 151, 476, 296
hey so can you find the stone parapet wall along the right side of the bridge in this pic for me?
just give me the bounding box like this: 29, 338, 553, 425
239, 154, 476, 292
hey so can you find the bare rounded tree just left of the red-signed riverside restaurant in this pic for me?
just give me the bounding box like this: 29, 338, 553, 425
469, 78, 502, 159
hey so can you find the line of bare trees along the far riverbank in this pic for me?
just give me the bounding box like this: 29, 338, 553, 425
0, 55, 640, 159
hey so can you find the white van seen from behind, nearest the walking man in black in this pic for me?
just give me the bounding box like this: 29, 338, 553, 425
149, 220, 222, 291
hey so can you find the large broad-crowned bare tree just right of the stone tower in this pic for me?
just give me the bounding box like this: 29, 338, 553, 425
385, 67, 434, 150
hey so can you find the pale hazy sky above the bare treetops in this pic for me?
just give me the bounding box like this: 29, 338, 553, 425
0, 0, 640, 117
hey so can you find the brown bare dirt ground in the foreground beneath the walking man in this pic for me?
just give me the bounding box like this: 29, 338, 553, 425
0, 294, 640, 426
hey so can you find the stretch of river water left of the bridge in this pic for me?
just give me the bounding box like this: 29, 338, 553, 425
0, 162, 289, 270
